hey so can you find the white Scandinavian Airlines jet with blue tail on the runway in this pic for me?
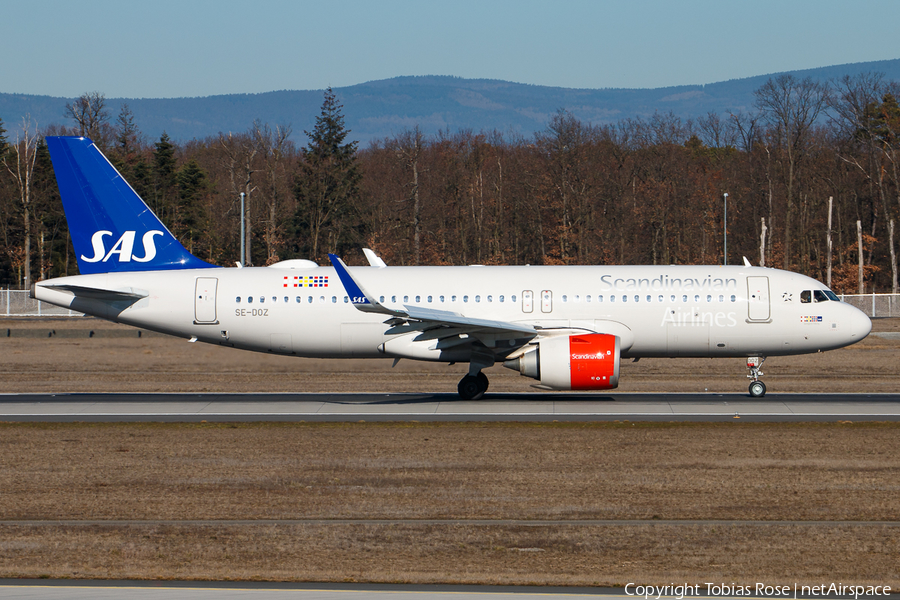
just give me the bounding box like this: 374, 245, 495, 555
31, 137, 872, 399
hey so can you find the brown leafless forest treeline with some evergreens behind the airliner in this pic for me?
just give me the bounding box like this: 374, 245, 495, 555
0, 73, 900, 293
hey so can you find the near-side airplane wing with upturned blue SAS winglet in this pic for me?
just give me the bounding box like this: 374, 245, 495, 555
328, 254, 538, 341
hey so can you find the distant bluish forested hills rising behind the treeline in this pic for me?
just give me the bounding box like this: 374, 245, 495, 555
0, 59, 900, 146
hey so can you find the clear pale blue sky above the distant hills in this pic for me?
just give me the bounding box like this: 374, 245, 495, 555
7, 0, 900, 98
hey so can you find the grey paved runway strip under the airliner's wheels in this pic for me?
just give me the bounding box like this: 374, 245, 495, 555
0, 393, 900, 422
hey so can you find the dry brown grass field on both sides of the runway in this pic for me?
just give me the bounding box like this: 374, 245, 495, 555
0, 319, 900, 588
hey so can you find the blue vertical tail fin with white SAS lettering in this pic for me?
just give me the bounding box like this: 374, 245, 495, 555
46, 137, 215, 274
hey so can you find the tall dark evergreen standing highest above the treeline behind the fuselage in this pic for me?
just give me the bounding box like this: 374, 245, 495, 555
294, 88, 360, 260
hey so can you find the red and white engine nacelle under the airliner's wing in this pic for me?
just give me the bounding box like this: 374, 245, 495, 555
504, 333, 619, 390
